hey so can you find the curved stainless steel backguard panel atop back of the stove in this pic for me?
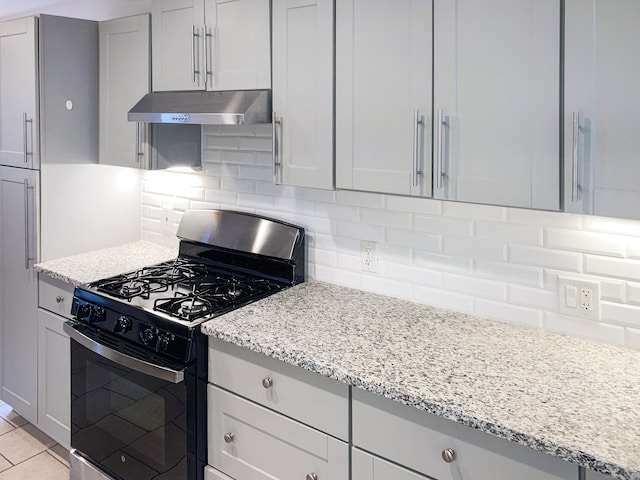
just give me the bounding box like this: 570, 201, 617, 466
176, 210, 300, 260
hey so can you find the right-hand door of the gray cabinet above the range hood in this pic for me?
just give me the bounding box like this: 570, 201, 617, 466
204, 0, 271, 90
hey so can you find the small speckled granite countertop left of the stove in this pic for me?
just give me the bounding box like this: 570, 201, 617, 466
34, 241, 178, 285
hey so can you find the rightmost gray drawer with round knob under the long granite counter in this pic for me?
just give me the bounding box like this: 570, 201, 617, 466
353, 389, 578, 480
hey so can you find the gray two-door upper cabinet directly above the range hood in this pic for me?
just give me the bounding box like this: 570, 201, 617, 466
151, 0, 271, 91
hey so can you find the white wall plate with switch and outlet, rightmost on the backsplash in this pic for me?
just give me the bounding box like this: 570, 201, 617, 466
558, 277, 600, 320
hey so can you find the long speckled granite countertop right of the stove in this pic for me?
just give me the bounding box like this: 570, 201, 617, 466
203, 282, 640, 480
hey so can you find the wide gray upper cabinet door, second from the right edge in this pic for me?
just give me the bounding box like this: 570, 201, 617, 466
433, 0, 561, 210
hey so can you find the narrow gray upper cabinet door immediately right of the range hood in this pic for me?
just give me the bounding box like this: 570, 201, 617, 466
273, 0, 334, 189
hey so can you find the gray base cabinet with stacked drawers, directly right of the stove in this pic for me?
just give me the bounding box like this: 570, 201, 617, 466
207, 339, 349, 480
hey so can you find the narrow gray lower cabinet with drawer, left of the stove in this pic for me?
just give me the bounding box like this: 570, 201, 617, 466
37, 276, 73, 447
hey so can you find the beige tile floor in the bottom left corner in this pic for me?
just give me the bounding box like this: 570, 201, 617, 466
0, 401, 69, 480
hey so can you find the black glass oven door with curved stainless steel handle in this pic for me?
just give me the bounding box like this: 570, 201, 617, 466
64, 323, 196, 480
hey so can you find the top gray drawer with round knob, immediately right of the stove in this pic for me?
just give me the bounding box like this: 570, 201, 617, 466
209, 338, 349, 440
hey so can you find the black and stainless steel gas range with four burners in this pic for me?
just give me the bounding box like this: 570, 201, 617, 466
65, 210, 305, 480
